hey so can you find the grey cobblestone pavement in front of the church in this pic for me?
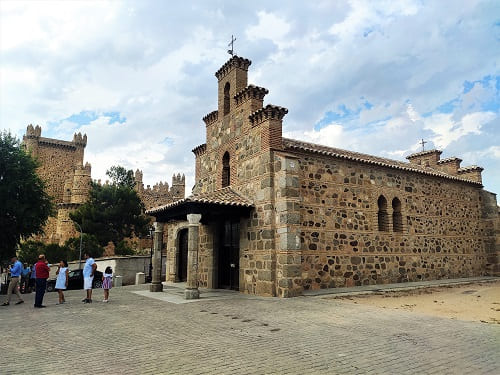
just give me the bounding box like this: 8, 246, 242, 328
0, 285, 500, 375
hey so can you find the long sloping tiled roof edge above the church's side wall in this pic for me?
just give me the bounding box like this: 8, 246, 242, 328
283, 138, 482, 186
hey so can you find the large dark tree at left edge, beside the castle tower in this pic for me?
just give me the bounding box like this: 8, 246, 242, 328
0, 131, 54, 259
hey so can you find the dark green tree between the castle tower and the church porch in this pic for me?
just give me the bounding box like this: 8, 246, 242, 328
70, 167, 149, 247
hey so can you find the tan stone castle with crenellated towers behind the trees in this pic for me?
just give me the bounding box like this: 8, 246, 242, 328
23, 124, 185, 245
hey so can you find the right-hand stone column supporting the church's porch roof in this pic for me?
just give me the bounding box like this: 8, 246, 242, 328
184, 214, 201, 299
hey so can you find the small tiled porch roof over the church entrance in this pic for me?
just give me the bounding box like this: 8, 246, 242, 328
146, 187, 253, 214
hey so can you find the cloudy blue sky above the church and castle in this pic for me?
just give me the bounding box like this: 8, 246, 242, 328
0, 0, 500, 198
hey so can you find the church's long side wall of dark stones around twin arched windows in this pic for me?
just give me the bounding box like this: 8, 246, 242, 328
294, 155, 490, 289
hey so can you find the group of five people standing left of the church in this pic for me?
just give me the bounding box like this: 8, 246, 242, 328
2, 253, 113, 308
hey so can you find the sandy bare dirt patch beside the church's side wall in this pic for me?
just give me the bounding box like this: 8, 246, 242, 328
334, 281, 500, 324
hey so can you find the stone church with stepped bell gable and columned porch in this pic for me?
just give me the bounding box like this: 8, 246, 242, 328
147, 56, 500, 298
